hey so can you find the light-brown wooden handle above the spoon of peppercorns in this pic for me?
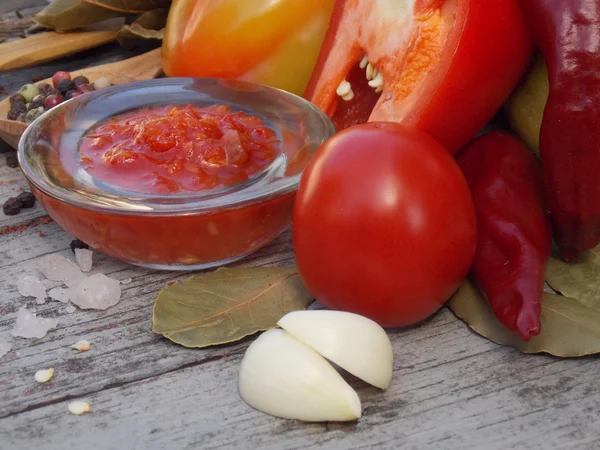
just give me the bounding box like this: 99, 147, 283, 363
0, 31, 117, 72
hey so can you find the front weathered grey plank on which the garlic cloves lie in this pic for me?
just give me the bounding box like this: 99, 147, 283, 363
0, 318, 600, 450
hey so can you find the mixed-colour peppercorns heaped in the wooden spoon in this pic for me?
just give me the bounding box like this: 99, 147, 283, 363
6, 72, 111, 124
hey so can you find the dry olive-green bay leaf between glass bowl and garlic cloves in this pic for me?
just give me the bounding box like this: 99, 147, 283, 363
152, 267, 313, 348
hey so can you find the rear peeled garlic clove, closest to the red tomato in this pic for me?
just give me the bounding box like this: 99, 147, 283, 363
277, 310, 394, 389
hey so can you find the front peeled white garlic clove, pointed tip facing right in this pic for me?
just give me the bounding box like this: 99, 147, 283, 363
239, 330, 362, 422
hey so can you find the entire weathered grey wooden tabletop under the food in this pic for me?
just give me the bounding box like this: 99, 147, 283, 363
0, 4, 600, 450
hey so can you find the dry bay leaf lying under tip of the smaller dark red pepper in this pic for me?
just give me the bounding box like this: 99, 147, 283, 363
448, 280, 600, 357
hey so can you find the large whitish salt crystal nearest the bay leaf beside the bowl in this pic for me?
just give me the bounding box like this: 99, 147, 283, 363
71, 273, 121, 309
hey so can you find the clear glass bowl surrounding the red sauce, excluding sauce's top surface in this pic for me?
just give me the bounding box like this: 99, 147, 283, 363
19, 78, 335, 270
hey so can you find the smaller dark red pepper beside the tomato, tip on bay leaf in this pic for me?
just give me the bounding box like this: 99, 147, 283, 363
458, 132, 552, 341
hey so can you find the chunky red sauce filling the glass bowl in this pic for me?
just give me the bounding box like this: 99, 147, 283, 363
34, 105, 295, 269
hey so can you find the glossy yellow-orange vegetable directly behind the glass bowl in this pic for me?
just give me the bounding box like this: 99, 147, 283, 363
162, 0, 334, 95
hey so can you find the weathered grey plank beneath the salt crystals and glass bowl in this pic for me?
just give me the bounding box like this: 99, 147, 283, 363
0, 218, 293, 417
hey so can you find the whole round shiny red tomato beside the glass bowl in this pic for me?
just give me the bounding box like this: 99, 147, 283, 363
293, 122, 477, 327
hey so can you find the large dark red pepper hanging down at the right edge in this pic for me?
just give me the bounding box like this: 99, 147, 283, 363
520, 0, 600, 261
